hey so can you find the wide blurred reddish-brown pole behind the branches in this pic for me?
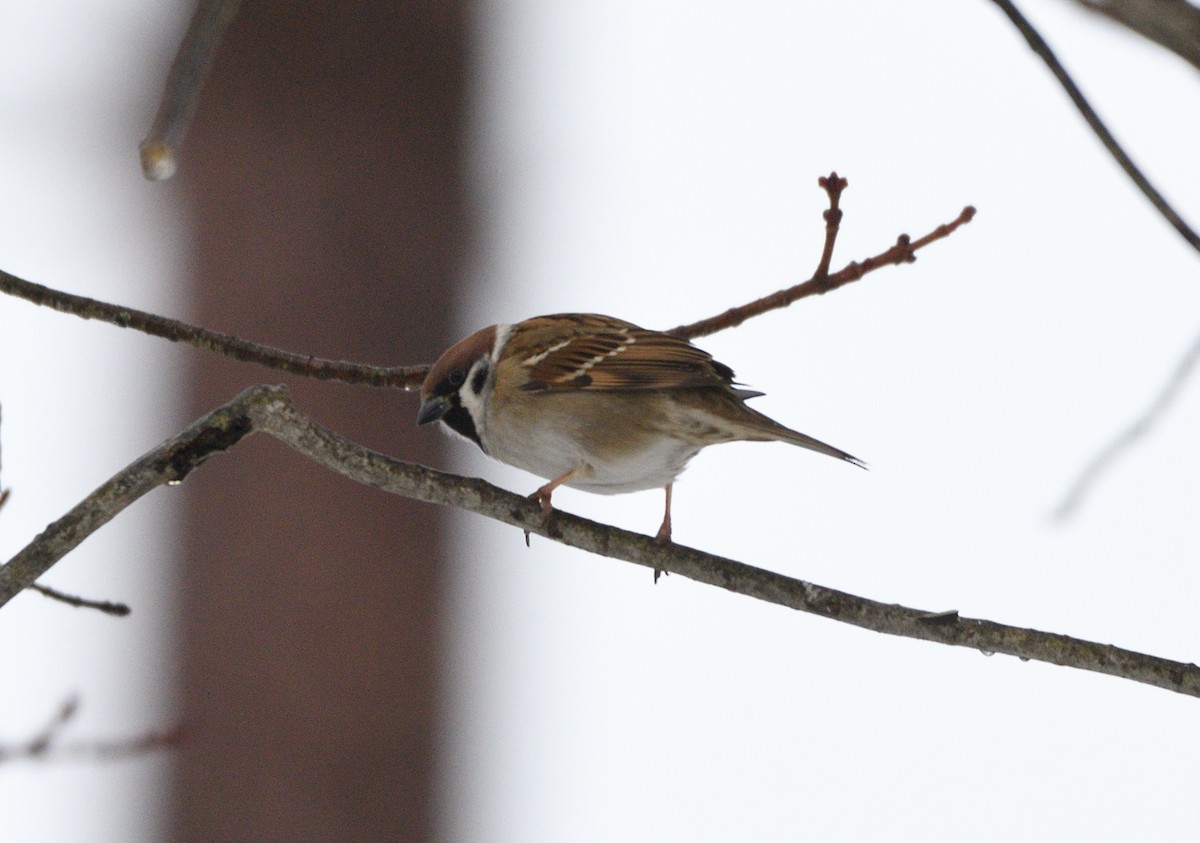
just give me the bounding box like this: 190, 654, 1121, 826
173, 0, 466, 843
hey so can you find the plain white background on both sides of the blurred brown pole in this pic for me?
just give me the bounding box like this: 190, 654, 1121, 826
0, 0, 1200, 842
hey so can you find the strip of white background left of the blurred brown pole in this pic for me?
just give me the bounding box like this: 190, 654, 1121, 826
0, 0, 188, 843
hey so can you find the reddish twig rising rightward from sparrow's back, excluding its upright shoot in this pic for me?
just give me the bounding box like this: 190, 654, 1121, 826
667, 205, 976, 340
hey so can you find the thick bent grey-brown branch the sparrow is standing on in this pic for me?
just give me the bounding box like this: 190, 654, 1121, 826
0, 385, 1200, 696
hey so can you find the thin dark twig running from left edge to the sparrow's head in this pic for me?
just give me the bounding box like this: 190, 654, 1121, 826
0, 270, 428, 389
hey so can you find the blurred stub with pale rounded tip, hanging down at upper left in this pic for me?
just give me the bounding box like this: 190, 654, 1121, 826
139, 0, 241, 181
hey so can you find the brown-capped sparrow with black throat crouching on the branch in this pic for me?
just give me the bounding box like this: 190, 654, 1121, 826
416, 313, 865, 543
